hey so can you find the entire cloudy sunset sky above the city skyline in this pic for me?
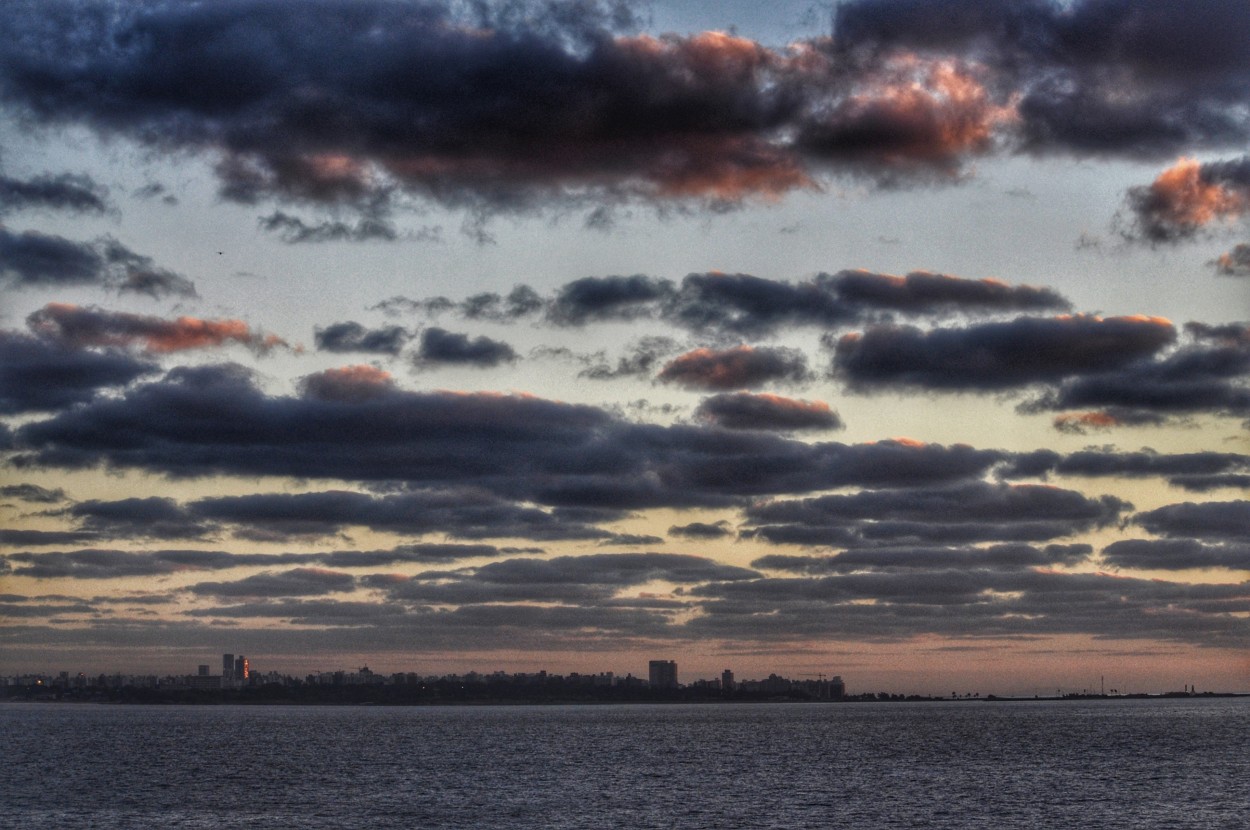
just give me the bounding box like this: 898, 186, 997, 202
0, 0, 1250, 695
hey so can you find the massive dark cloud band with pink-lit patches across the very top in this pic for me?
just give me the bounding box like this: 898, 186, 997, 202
0, 0, 1250, 215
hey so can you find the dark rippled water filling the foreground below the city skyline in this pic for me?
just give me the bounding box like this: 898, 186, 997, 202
0, 699, 1250, 830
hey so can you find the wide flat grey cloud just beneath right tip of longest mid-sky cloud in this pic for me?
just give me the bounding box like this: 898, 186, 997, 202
744, 481, 1131, 546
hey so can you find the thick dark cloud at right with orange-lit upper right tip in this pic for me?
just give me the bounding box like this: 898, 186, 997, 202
834, 315, 1176, 390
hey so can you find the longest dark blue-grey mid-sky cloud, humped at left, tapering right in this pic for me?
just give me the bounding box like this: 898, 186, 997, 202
11, 365, 1009, 509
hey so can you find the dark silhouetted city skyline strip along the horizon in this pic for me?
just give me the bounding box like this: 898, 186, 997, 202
0, 654, 1233, 704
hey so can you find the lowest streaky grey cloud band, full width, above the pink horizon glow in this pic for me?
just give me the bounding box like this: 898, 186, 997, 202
4, 565, 1250, 654
